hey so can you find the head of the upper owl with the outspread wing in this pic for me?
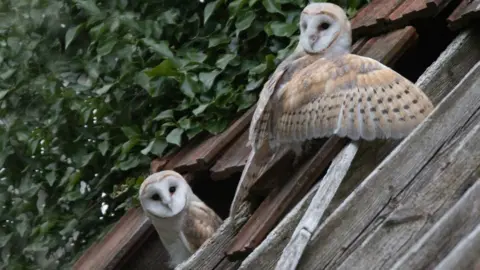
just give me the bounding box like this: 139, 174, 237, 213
299, 3, 352, 54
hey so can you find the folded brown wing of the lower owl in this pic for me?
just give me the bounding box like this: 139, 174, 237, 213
182, 200, 222, 252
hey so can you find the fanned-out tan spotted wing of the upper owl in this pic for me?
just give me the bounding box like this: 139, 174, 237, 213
270, 54, 433, 145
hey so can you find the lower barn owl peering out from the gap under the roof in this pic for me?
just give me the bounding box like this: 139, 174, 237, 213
139, 170, 222, 267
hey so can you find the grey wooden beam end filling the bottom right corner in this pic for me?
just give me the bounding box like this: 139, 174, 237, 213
436, 221, 480, 270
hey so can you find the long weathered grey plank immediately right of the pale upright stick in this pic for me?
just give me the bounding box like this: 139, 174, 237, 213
299, 63, 480, 269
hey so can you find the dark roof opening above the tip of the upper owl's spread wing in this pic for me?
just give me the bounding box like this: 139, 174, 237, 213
394, 0, 461, 82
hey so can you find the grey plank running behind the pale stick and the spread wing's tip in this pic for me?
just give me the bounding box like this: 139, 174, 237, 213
235, 27, 480, 270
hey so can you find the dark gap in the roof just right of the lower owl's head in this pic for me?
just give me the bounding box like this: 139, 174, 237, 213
191, 171, 241, 219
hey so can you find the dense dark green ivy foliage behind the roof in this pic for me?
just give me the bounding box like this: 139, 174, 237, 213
0, 0, 365, 269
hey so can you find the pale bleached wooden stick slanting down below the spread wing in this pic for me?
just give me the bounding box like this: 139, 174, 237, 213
276, 142, 358, 270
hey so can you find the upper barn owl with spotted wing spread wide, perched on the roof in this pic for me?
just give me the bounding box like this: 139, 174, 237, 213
230, 3, 433, 222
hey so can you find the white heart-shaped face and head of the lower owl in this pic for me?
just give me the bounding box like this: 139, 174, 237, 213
139, 170, 192, 218
